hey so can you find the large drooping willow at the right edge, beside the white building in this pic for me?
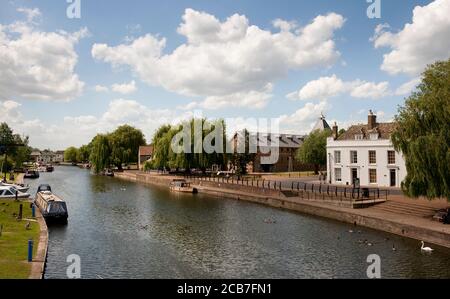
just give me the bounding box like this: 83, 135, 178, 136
392, 60, 450, 200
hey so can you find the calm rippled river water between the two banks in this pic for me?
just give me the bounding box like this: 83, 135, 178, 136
26, 166, 450, 279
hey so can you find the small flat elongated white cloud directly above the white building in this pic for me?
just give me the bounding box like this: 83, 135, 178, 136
287, 75, 391, 101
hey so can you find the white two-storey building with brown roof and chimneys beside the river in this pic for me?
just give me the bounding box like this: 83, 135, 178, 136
327, 111, 406, 187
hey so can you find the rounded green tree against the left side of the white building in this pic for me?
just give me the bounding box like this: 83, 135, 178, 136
296, 130, 332, 175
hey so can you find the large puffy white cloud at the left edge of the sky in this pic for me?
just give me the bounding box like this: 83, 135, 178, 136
0, 9, 88, 101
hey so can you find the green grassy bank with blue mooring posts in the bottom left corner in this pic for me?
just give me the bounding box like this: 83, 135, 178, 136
0, 200, 39, 279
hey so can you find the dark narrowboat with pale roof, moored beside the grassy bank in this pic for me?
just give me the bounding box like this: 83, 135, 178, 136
34, 185, 69, 224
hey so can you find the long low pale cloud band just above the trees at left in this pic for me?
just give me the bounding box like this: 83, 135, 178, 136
0, 99, 193, 150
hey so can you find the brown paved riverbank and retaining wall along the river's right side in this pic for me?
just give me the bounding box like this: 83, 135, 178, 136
116, 171, 450, 248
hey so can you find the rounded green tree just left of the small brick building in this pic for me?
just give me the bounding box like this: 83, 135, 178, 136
108, 125, 146, 170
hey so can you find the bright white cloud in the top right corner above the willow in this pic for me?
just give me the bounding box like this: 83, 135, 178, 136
372, 0, 450, 76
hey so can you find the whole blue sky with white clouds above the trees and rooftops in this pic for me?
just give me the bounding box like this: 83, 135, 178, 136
0, 0, 450, 150
